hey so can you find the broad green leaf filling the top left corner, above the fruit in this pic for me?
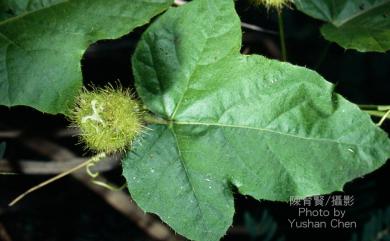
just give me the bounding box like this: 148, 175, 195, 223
0, 0, 172, 114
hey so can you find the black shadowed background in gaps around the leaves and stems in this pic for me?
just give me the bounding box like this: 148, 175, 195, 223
0, 0, 390, 241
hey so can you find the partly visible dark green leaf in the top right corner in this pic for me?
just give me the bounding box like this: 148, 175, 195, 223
294, 0, 390, 52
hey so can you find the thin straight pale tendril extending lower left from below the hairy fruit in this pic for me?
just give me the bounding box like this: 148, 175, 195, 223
8, 152, 107, 206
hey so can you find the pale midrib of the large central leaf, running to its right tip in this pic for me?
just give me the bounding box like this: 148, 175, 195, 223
172, 121, 372, 148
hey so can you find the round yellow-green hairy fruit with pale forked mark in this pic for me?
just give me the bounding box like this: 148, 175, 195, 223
71, 87, 142, 153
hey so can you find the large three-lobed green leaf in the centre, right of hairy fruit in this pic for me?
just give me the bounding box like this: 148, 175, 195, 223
123, 0, 390, 241
